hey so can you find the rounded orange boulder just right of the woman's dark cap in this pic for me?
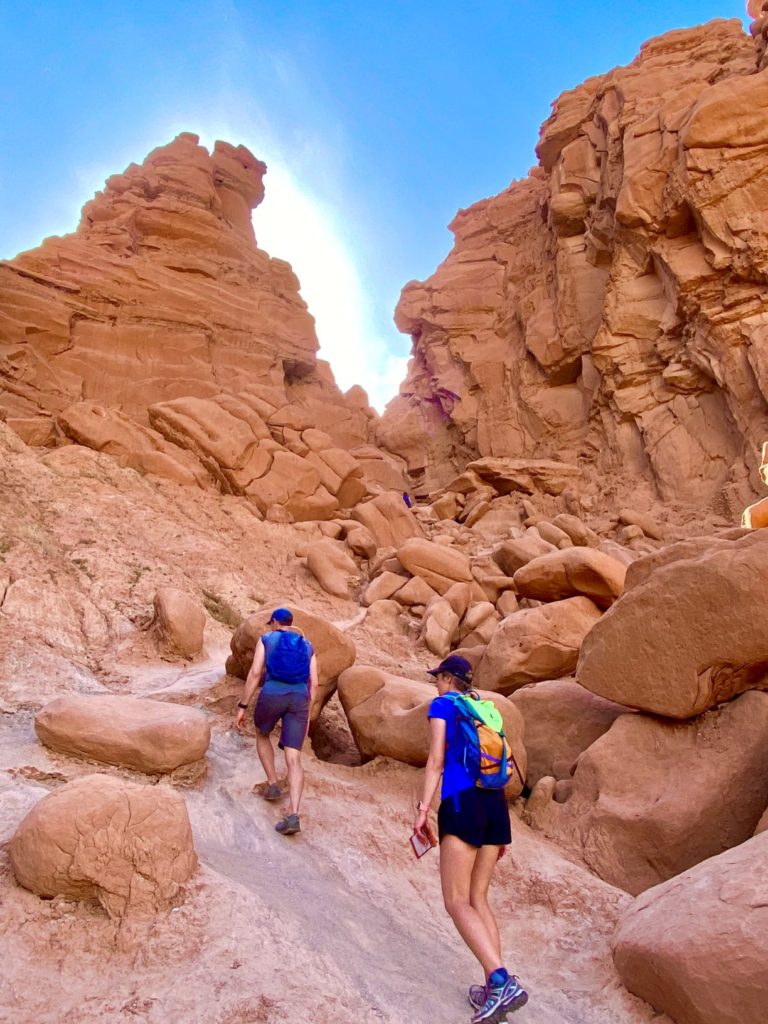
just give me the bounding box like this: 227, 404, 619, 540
476, 597, 601, 693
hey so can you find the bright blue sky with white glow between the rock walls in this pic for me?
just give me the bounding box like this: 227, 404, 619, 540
0, 0, 744, 409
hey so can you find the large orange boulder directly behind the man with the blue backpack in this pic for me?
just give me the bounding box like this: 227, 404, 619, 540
226, 601, 356, 723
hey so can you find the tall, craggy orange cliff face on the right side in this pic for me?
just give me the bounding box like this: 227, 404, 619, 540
377, 22, 768, 514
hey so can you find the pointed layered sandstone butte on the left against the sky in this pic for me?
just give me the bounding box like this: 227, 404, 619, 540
0, 133, 403, 520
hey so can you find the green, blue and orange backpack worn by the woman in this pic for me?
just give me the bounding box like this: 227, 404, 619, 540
451, 691, 525, 790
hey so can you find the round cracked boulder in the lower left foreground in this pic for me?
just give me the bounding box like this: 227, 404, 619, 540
9, 775, 198, 919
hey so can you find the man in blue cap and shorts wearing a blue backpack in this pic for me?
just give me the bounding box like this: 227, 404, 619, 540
236, 608, 317, 836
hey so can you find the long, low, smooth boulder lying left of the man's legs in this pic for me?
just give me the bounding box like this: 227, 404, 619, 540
35, 694, 211, 774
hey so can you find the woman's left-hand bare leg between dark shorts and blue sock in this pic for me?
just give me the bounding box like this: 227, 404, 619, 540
440, 836, 502, 977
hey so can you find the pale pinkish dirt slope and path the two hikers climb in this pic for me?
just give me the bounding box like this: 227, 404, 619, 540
0, 435, 671, 1024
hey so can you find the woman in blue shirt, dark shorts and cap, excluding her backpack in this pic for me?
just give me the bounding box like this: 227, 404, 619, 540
414, 654, 528, 1024
